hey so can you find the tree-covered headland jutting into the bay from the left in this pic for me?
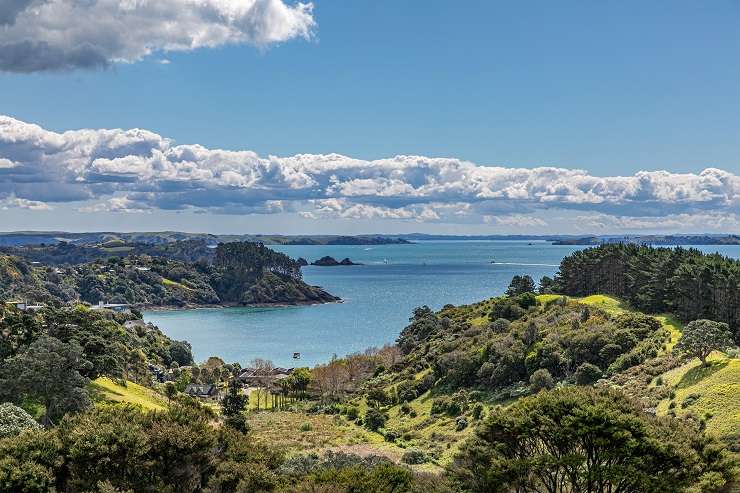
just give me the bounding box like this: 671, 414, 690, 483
0, 240, 337, 306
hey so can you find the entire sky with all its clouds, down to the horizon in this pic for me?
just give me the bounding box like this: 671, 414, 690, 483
0, 0, 740, 234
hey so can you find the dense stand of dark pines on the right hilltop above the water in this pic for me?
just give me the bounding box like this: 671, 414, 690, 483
547, 244, 740, 342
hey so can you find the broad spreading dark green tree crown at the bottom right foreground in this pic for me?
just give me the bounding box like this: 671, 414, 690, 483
456, 387, 731, 493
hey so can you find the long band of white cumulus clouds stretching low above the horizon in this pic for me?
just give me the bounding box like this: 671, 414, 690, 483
0, 116, 740, 229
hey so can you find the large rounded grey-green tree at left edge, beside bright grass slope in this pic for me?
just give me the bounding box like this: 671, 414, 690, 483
0, 335, 90, 426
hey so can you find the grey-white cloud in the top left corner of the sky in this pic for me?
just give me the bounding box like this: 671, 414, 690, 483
0, 0, 315, 73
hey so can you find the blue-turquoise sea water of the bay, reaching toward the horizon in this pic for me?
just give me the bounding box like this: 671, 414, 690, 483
144, 241, 740, 366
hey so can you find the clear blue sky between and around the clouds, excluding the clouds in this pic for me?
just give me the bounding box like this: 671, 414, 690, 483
0, 0, 740, 233
